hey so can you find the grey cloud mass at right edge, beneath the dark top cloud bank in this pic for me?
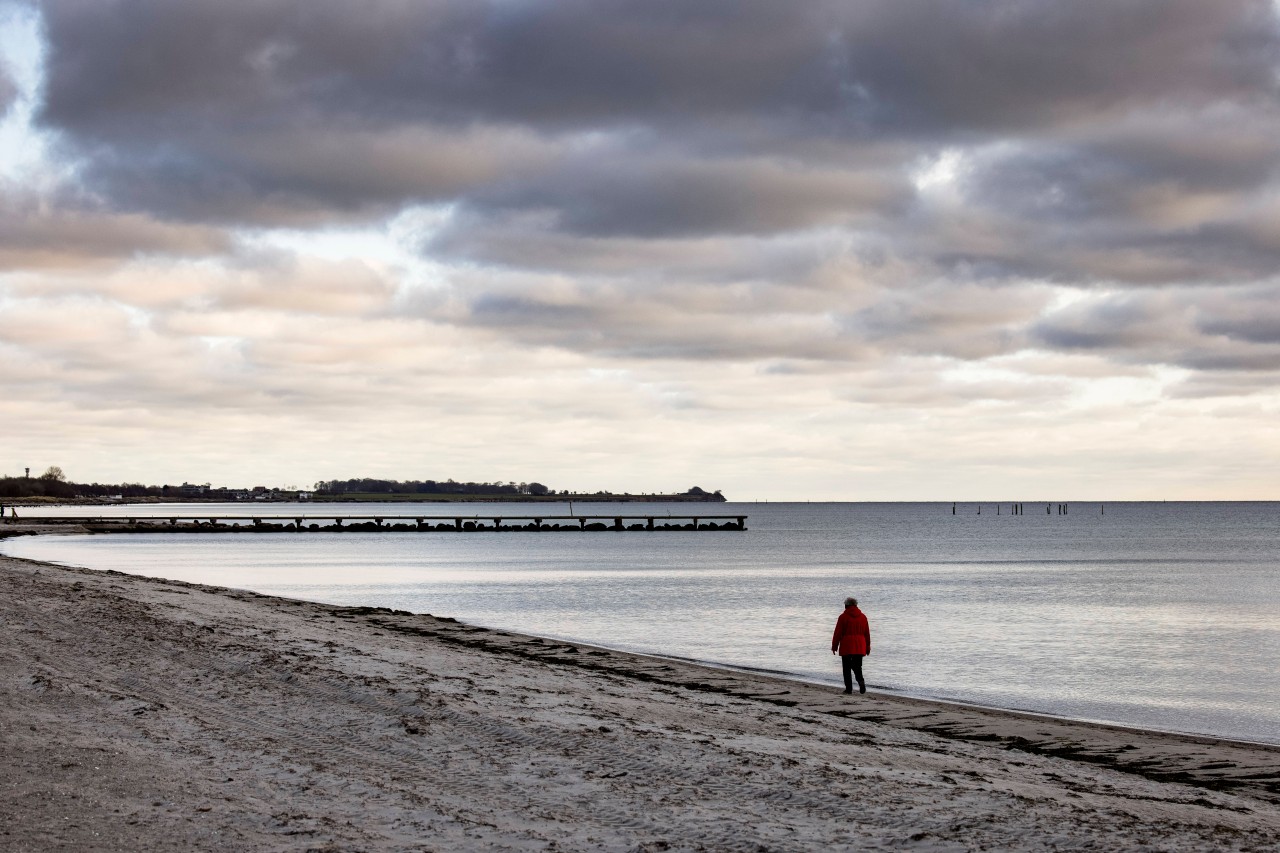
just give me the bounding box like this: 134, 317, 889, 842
896, 102, 1280, 286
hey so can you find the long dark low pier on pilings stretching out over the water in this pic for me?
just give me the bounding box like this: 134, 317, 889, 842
20, 512, 746, 533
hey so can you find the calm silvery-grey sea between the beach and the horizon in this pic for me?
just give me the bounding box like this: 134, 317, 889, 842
0, 503, 1280, 743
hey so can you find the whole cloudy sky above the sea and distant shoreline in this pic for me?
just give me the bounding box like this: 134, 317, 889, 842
0, 0, 1280, 501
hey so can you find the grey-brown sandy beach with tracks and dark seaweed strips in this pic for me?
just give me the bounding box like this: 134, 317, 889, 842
0, 540, 1280, 850
